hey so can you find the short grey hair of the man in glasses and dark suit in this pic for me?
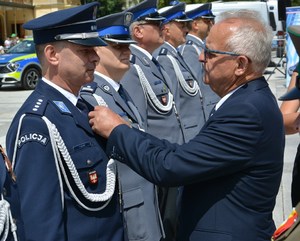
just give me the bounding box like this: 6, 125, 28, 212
218, 9, 273, 72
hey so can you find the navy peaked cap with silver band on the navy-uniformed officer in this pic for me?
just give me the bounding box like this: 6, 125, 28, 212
23, 2, 106, 46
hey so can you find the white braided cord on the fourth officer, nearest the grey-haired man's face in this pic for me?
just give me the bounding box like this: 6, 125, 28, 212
166, 54, 199, 96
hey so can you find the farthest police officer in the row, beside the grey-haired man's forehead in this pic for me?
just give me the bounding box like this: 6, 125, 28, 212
179, 3, 220, 119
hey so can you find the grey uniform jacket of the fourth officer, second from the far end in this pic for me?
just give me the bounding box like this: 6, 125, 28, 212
153, 42, 206, 142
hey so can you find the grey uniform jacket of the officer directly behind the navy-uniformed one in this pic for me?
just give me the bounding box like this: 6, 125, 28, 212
82, 74, 163, 241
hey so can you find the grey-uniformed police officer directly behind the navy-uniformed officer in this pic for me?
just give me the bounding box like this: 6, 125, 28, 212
80, 12, 164, 241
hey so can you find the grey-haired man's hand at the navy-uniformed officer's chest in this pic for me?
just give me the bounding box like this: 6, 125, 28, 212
89, 106, 130, 138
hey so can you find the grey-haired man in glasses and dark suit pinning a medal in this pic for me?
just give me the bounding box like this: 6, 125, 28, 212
89, 10, 285, 241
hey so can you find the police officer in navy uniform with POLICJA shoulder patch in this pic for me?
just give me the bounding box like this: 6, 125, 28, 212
6, 2, 124, 241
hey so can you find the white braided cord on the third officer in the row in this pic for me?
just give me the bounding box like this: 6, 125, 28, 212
133, 64, 173, 115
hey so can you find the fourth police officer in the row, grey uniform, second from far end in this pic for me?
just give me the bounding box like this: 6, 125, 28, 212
153, 2, 205, 142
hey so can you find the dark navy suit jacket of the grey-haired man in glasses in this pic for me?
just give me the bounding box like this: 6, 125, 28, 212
107, 77, 285, 241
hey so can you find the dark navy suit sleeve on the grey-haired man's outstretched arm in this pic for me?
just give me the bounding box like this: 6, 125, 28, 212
107, 103, 264, 186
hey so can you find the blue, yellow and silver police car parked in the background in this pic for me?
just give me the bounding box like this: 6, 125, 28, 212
0, 38, 42, 90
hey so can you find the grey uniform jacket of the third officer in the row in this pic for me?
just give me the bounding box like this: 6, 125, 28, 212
121, 46, 185, 144
